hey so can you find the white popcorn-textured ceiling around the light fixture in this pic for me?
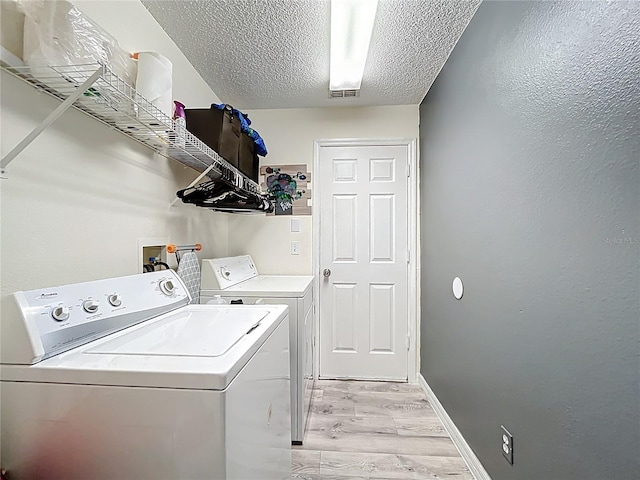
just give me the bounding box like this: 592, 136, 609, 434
142, 0, 480, 109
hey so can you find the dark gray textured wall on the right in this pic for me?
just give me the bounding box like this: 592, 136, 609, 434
420, 1, 640, 480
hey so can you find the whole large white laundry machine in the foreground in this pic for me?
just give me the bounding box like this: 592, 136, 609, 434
0, 270, 291, 480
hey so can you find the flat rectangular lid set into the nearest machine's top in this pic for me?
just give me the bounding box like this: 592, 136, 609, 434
85, 307, 269, 357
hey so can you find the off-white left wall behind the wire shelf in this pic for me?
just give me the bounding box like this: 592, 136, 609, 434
0, 0, 228, 304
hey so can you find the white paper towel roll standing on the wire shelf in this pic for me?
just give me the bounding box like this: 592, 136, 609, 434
136, 52, 173, 118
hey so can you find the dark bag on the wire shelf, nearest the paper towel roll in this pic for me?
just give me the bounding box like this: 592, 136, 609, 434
184, 105, 241, 168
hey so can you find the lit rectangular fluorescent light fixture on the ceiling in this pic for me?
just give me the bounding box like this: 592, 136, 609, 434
329, 0, 378, 90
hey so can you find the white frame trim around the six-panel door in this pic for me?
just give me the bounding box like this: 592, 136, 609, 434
311, 138, 420, 383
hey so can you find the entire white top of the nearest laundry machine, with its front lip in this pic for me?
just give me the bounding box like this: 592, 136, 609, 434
0, 305, 289, 390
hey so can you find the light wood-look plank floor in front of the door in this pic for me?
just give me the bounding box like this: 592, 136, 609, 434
291, 380, 473, 480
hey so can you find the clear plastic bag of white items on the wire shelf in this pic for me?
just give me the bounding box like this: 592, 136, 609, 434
17, 0, 136, 86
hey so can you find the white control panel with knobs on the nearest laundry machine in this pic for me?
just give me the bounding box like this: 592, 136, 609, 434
10, 270, 191, 363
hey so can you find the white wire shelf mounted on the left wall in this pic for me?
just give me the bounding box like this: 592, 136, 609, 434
0, 64, 261, 194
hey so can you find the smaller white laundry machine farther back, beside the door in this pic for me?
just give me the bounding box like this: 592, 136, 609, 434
200, 255, 315, 445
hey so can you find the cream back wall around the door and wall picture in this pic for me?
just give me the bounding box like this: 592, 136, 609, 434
229, 104, 419, 275
